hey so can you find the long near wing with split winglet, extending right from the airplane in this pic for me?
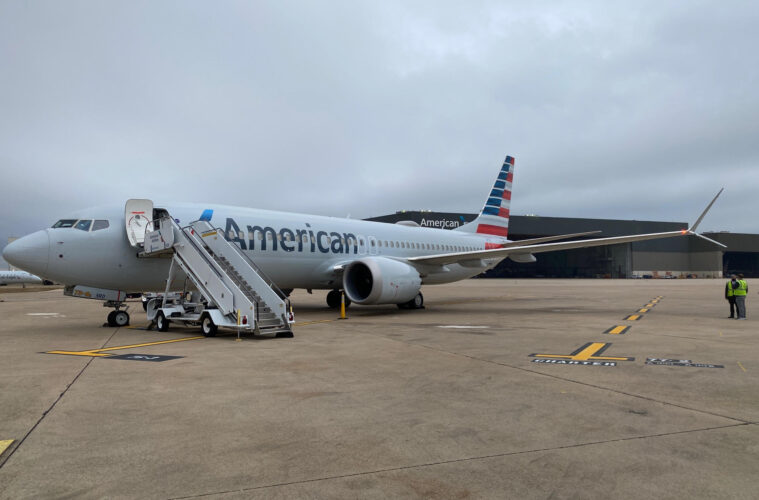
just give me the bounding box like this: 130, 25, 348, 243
406, 190, 725, 266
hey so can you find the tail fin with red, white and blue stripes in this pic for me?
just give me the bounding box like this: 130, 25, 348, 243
456, 156, 514, 238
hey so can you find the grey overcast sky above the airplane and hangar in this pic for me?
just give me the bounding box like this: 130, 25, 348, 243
0, 0, 759, 266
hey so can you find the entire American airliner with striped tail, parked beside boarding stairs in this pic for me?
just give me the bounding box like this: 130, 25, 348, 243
3, 156, 724, 324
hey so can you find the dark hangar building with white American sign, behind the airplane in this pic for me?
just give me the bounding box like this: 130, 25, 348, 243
367, 210, 759, 278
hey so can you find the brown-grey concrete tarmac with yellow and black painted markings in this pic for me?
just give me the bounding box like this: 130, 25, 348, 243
0, 280, 759, 499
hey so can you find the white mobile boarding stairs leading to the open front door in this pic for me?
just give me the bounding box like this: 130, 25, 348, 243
138, 214, 293, 336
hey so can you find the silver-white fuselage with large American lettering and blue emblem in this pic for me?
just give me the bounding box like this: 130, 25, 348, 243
6, 204, 508, 292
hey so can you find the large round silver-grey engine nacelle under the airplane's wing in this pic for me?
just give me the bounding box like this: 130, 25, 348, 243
343, 257, 422, 305
